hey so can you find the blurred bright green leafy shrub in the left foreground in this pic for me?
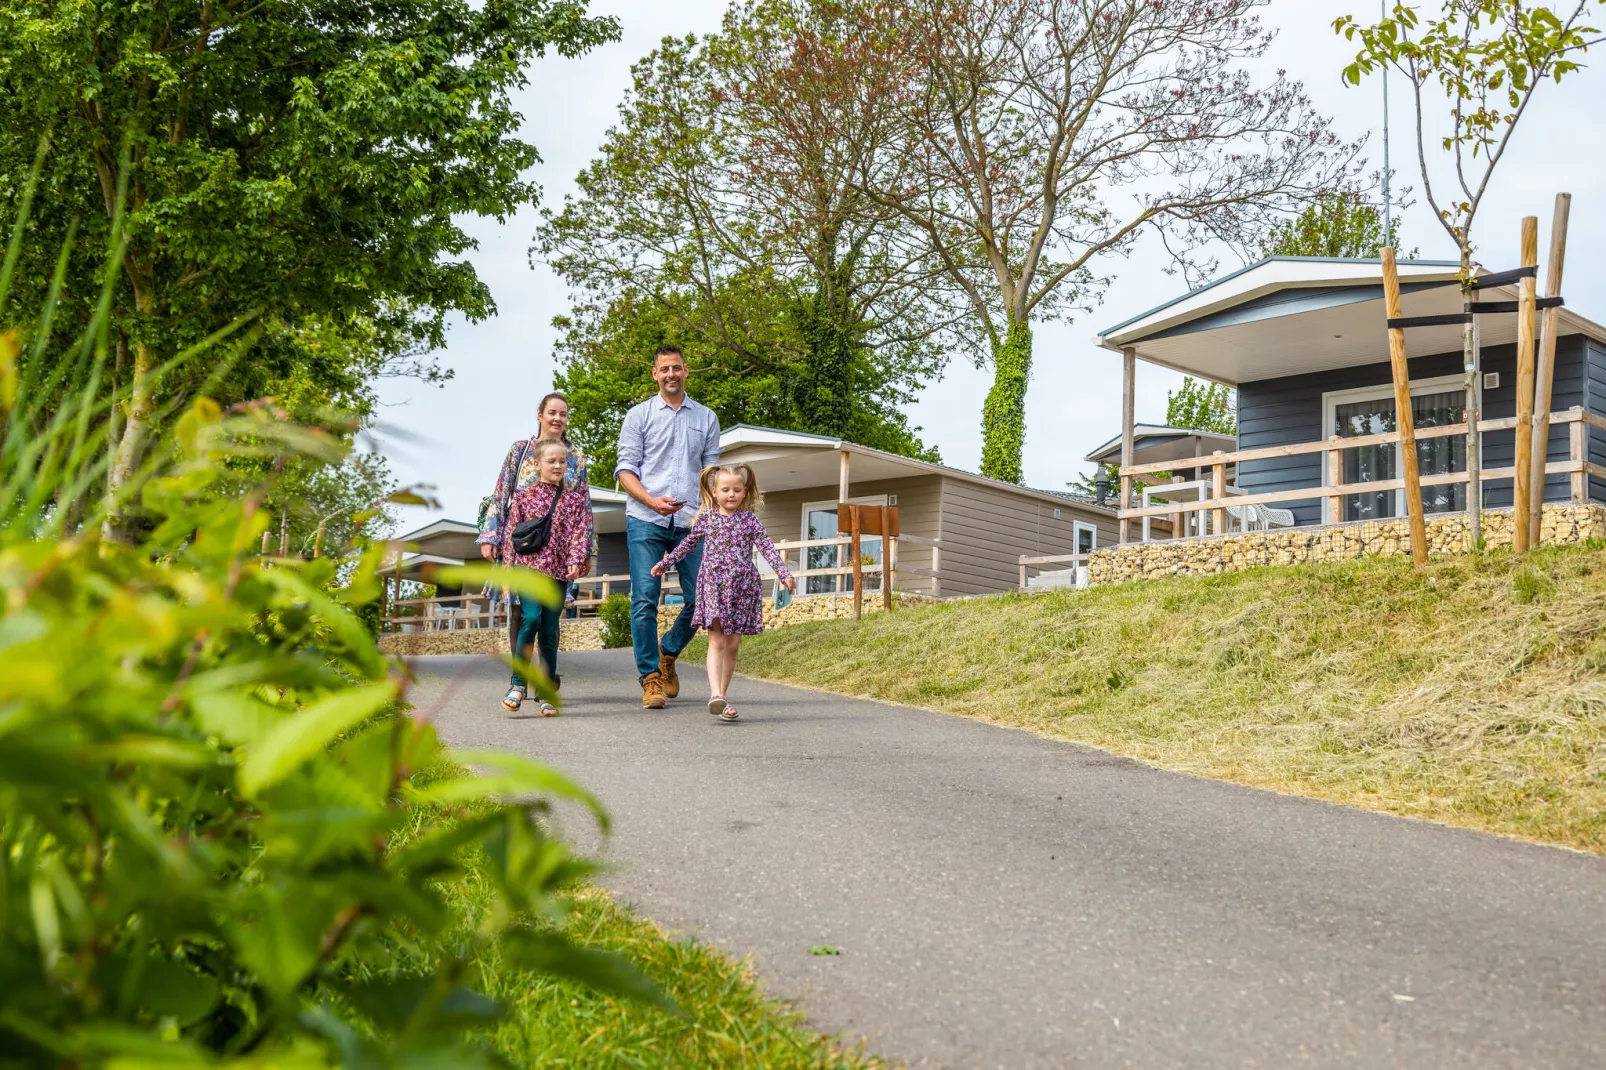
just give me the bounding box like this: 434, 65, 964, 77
0, 179, 657, 1067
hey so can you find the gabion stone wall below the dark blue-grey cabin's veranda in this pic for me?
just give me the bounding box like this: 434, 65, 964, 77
1087, 503, 1606, 585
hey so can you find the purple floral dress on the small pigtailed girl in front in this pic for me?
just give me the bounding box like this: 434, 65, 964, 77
663, 509, 792, 635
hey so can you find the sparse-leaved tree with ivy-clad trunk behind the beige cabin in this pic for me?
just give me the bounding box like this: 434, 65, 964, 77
859, 0, 1359, 482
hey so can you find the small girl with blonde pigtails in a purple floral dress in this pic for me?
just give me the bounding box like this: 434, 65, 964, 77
652, 464, 798, 723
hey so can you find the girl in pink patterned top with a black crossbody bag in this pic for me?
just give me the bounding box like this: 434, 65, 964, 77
501, 439, 591, 717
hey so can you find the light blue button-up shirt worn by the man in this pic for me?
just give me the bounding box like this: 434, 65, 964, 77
613, 394, 719, 527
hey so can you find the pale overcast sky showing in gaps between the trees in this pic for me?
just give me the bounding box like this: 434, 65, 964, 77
381, 0, 1606, 532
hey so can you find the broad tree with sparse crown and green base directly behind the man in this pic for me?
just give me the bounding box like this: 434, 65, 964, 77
532, 0, 951, 453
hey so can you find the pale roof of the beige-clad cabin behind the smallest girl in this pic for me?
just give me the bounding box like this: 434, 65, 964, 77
719, 424, 1115, 514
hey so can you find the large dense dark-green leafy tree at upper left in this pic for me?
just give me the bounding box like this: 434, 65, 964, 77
0, 0, 618, 517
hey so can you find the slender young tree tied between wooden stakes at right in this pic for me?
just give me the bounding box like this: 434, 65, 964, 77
1333, 0, 1606, 543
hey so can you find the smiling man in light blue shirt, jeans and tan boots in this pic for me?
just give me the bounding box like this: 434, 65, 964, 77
613, 345, 719, 710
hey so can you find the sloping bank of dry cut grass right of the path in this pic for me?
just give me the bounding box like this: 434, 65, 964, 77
709, 546, 1606, 852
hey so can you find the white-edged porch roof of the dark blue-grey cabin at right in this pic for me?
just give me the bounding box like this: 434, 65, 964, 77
1095, 257, 1606, 386
